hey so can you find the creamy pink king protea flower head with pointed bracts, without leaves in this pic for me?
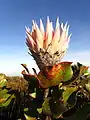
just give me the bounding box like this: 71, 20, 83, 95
26, 17, 71, 69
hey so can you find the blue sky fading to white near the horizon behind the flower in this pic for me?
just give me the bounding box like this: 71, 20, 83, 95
0, 0, 90, 75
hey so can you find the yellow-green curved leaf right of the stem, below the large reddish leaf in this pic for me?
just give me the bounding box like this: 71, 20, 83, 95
63, 87, 78, 103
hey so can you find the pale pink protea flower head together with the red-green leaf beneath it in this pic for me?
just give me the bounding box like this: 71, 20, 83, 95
26, 17, 73, 88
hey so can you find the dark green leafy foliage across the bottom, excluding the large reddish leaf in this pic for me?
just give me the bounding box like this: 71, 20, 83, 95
0, 63, 90, 120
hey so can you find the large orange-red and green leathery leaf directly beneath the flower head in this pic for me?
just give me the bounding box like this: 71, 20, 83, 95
37, 62, 73, 88
